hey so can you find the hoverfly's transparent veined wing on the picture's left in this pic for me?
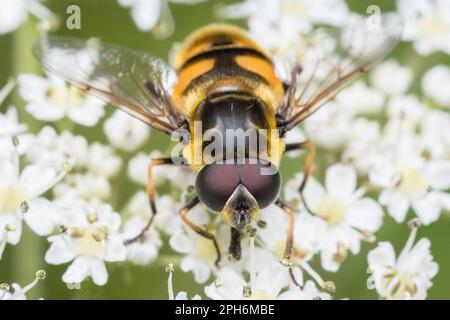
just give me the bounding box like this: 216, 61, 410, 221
33, 36, 185, 134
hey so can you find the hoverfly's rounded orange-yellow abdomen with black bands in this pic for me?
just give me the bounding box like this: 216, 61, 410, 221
172, 24, 284, 117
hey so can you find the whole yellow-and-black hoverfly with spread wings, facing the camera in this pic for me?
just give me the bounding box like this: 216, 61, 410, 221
34, 16, 401, 281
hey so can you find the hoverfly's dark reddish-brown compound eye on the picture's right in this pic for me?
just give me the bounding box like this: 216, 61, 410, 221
239, 163, 281, 209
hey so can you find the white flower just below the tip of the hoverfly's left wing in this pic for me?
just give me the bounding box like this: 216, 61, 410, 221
18, 74, 105, 126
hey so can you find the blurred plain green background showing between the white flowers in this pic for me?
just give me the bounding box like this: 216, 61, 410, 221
0, 0, 450, 299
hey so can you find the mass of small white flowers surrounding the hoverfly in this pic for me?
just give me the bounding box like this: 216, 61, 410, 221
0, 0, 450, 300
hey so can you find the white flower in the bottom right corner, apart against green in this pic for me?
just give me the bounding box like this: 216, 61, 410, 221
367, 222, 439, 300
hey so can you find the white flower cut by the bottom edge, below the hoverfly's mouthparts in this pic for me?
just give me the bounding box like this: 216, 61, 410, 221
205, 264, 288, 300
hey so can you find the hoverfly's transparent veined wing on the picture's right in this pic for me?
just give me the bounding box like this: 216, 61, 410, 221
278, 14, 402, 130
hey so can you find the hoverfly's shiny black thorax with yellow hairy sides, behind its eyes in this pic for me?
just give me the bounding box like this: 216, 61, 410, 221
180, 92, 284, 172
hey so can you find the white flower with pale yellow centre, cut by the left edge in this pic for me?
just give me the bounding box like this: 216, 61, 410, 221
0, 154, 66, 257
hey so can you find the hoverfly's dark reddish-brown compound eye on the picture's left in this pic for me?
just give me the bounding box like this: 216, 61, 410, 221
195, 164, 240, 212
